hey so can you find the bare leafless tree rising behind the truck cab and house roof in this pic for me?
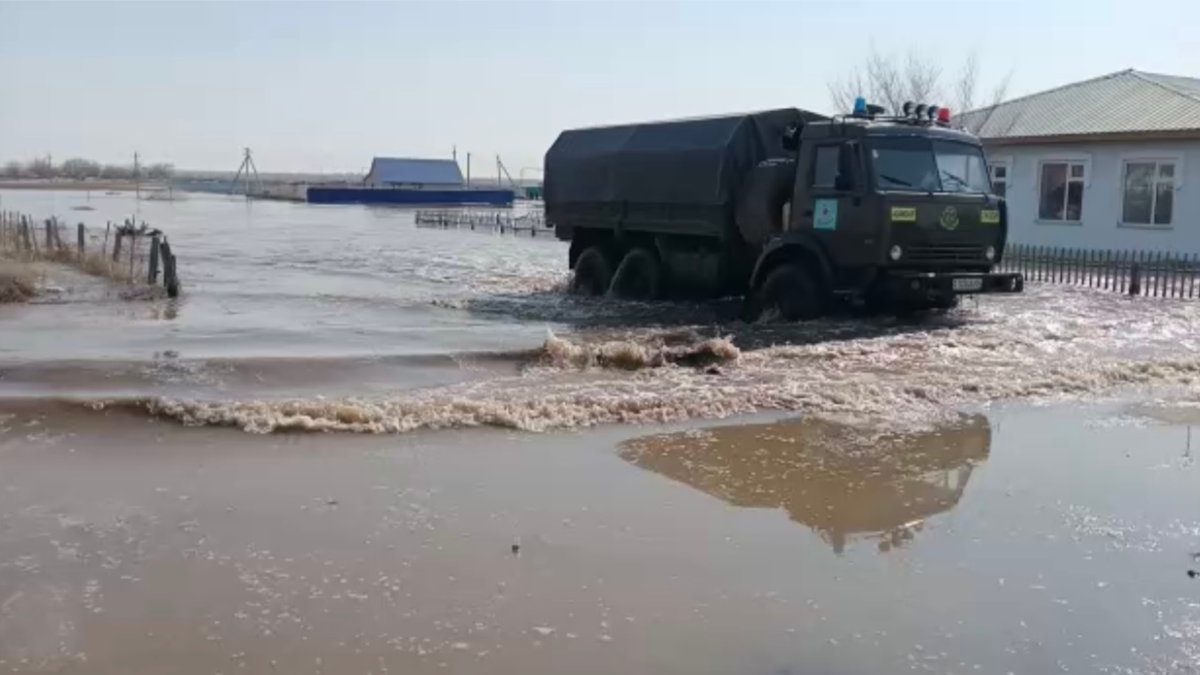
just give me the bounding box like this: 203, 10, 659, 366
829, 48, 1012, 119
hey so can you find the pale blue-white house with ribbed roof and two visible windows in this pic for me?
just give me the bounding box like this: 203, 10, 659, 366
958, 70, 1200, 253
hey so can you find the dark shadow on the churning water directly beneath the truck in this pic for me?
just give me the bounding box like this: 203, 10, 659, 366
456, 289, 978, 350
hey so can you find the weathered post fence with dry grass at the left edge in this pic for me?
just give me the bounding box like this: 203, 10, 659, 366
0, 211, 180, 298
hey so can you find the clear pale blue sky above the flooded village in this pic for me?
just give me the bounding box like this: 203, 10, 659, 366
0, 0, 1200, 175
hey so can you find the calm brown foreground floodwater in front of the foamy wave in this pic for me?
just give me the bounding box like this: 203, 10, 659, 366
0, 406, 1200, 674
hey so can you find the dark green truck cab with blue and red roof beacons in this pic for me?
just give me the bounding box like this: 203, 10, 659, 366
751, 106, 1024, 316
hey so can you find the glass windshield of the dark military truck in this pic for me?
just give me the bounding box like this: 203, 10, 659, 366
870, 138, 991, 193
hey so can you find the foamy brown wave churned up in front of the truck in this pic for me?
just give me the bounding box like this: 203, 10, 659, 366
11, 282, 1200, 432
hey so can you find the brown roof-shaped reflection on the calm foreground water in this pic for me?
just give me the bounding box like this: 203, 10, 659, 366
618, 416, 991, 554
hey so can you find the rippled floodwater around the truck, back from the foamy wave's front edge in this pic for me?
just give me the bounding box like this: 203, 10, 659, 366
0, 186, 1200, 432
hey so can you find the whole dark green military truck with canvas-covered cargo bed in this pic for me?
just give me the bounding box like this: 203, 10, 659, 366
545, 100, 1024, 319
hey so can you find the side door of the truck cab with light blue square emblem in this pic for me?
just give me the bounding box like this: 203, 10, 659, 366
799, 141, 878, 265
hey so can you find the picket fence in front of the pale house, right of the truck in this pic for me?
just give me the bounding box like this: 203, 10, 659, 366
998, 244, 1200, 298
